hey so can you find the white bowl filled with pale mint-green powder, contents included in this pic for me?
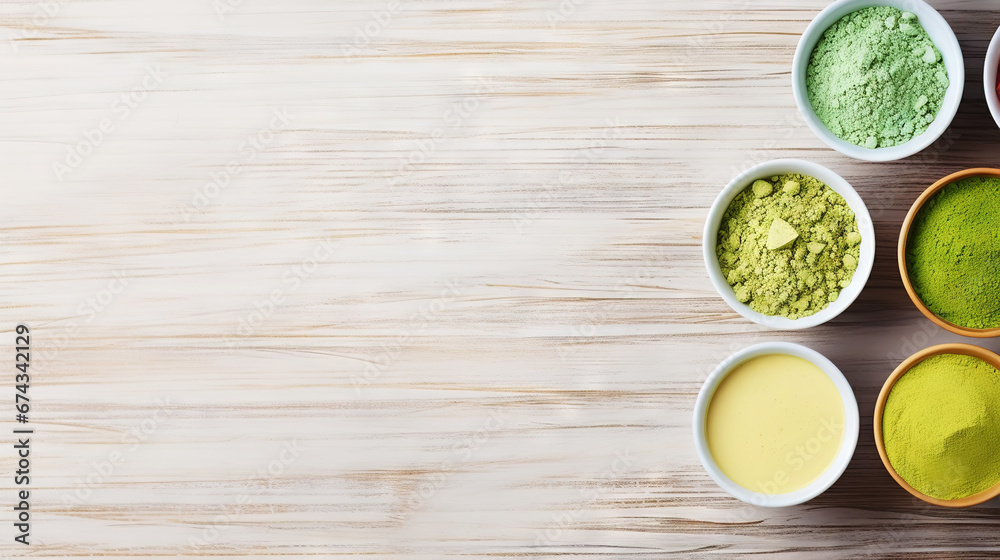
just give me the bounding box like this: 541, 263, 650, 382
792, 0, 965, 161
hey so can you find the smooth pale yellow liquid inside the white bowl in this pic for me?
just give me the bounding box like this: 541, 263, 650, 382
705, 354, 844, 494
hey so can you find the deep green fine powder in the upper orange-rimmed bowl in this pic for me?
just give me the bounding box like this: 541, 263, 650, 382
906, 177, 1000, 329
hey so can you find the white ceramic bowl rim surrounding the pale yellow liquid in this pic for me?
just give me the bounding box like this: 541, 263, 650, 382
694, 342, 861, 507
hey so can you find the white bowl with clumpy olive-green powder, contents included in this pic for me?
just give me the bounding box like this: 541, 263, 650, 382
702, 159, 875, 329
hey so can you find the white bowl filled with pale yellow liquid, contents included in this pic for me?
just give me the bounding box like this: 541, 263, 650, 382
694, 342, 860, 507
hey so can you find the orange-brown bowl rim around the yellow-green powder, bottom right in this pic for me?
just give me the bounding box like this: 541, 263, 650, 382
873, 343, 1000, 508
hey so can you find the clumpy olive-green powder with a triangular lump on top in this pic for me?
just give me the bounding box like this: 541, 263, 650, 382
716, 174, 861, 319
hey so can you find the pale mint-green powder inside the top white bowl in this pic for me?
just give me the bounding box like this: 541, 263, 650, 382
806, 7, 949, 149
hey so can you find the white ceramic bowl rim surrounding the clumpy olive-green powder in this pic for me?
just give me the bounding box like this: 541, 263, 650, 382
702, 159, 875, 330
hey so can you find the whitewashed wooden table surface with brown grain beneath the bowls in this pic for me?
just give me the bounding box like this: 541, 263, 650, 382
0, 0, 1000, 559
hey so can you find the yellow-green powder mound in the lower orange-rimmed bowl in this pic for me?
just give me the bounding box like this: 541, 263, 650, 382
882, 354, 1000, 500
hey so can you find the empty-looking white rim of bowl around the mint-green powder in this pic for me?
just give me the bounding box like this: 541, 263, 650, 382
792, 0, 964, 161
